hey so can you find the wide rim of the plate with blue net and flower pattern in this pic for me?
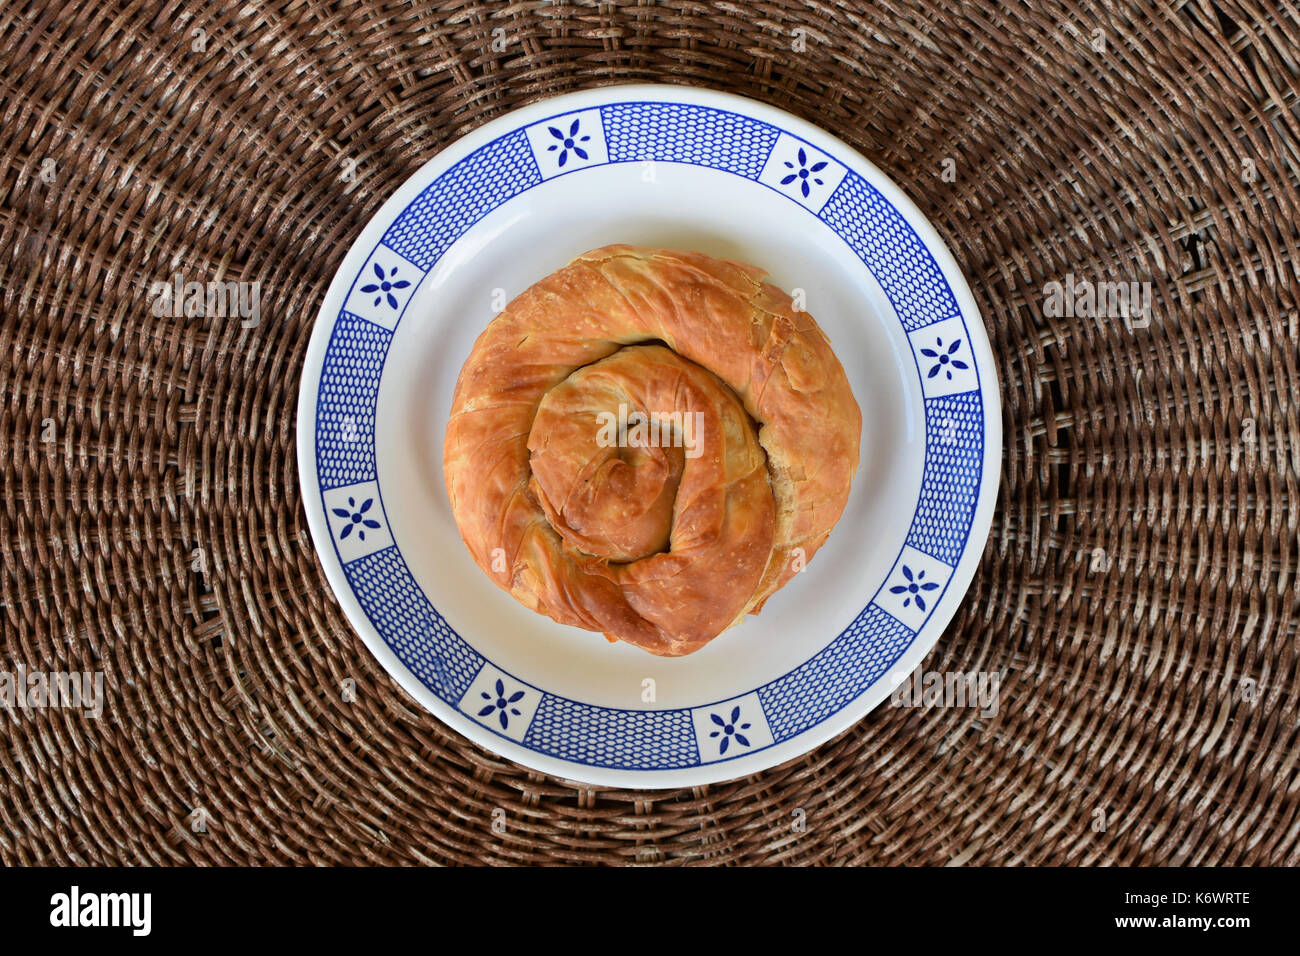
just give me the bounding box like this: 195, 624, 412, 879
298, 85, 1001, 788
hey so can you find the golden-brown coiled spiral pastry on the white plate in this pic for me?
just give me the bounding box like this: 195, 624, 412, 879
443, 246, 862, 657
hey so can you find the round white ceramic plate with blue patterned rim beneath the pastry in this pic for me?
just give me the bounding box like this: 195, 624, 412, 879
298, 86, 1001, 787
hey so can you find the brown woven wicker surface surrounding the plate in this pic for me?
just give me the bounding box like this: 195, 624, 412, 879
0, 0, 1300, 864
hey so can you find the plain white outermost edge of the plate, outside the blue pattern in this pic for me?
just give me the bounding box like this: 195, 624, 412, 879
296, 83, 1002, 790
